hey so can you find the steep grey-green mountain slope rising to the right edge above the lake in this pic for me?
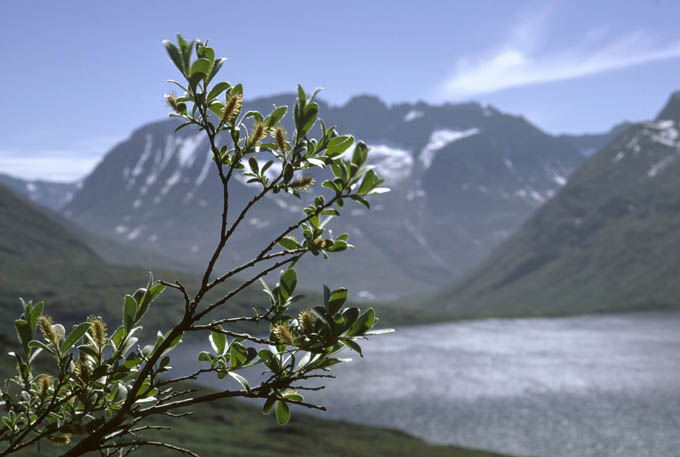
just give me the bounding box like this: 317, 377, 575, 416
431, 92, 680, 315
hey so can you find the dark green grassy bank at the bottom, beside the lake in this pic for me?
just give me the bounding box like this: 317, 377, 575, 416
111, 386, 516, 457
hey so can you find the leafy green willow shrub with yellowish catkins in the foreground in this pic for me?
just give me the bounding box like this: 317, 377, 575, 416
0, 36, 386, 457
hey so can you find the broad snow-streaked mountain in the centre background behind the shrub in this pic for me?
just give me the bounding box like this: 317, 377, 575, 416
63, 94, 583, 298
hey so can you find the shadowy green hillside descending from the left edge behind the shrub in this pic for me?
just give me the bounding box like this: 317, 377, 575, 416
0, 185, 450, 338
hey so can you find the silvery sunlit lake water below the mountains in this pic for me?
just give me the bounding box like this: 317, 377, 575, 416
175, 312, 680, 457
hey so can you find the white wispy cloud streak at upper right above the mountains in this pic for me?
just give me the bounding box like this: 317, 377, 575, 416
437, 10, 680, 99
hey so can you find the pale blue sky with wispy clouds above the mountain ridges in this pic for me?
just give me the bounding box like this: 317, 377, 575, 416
0, 0, 680, 180
